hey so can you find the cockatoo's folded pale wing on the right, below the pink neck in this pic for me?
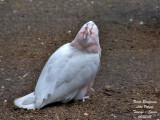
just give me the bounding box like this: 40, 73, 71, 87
54, 54, 100, 101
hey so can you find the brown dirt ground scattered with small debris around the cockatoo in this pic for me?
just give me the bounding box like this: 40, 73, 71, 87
0, 0, 160, 120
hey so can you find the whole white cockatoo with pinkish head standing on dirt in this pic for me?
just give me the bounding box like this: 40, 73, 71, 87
14, 21, 101, 109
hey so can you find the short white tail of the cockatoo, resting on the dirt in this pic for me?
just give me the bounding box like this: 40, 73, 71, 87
14, 92, 35, 110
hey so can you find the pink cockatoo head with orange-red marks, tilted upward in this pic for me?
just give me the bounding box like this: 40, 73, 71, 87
71, 21, 101, 54
